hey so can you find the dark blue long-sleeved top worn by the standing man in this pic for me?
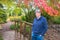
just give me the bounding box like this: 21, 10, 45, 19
32, 16, 48, 36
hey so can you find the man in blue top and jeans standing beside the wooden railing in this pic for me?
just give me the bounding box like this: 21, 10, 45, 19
32, 9, 48, 40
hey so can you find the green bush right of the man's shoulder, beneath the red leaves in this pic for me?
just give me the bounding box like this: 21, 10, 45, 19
42, 10, 60, 24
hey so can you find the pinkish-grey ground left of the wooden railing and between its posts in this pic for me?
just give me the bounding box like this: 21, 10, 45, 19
2, 22, 27, 40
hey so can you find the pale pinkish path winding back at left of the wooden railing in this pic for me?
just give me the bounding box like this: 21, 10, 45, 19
2, 22, 15, 40
